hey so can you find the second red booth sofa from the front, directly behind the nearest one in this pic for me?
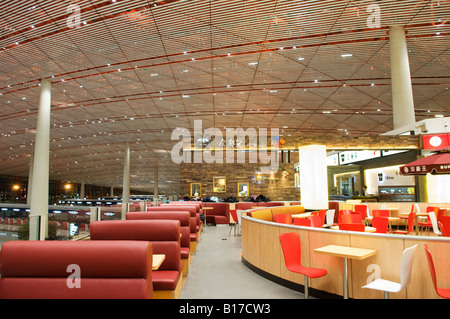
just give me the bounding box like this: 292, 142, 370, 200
90, 220, 183, 299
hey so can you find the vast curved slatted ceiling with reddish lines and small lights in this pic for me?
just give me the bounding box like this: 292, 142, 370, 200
0, 0, 450, 194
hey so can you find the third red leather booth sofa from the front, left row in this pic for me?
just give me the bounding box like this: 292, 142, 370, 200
127, 211, 195, 276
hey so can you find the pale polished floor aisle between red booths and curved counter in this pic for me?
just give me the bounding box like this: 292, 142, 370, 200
180, 225, 311, 299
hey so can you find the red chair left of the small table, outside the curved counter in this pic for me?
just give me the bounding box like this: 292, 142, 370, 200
280, 233, 327, 299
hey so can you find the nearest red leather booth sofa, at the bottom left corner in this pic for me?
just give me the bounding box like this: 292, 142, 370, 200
0, 241, 153, 299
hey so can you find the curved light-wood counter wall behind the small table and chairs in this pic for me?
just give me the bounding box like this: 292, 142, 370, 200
241, 216, 450, 299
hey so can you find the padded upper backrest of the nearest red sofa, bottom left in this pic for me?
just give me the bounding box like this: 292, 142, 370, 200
0, 241, 153, 279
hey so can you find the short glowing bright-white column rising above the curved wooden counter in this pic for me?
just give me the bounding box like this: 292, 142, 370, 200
299, 145, 328, 210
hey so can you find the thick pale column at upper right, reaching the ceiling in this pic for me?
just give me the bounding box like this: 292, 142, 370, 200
389, 25, 416, 129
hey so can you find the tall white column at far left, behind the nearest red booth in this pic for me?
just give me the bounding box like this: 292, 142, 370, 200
29, 80, 51, 240
